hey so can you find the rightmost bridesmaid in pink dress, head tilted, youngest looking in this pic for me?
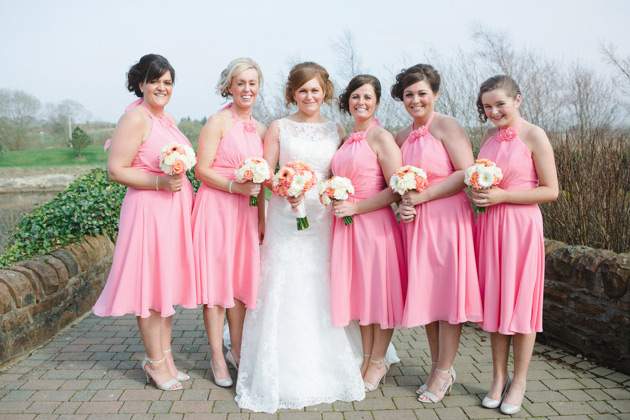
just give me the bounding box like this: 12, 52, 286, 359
473, 76, 558, 414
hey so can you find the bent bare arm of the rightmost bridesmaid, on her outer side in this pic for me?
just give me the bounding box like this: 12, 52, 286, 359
473, 125, 558, 207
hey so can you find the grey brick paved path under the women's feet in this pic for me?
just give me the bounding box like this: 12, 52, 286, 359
0, 309, 630, 420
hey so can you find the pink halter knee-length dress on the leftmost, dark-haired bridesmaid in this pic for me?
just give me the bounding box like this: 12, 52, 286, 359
93, 100, 197, 318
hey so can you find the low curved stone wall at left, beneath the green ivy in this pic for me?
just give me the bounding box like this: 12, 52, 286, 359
0, 236, 114, 366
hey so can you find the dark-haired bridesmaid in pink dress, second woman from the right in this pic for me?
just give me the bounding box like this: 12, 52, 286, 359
392, 64, 483, 403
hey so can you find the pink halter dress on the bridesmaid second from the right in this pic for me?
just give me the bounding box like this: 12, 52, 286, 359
401, 113, 483, 327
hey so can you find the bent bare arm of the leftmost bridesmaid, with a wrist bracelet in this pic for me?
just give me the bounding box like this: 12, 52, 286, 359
107, 110, 183, 191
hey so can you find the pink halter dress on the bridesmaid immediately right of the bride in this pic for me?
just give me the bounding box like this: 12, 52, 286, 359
330, 120, 407, 329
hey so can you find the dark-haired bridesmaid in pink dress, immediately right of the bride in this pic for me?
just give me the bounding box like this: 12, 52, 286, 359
330, 75, 407, 391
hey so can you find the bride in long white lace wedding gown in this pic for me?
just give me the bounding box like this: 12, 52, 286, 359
236, 62, 365, 413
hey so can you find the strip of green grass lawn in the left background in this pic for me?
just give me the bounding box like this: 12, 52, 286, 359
0, 146, 107, 168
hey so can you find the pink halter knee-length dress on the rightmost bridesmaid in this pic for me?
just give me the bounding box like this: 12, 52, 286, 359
476, 119, 545, 335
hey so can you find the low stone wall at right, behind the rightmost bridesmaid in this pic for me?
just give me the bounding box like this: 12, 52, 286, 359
539, 240, 630, 374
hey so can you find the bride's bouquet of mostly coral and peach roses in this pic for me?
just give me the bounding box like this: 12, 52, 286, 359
272, 162, 317, 230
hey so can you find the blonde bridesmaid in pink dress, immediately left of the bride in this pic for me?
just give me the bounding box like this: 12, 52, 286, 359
192, 58, 266, 387
